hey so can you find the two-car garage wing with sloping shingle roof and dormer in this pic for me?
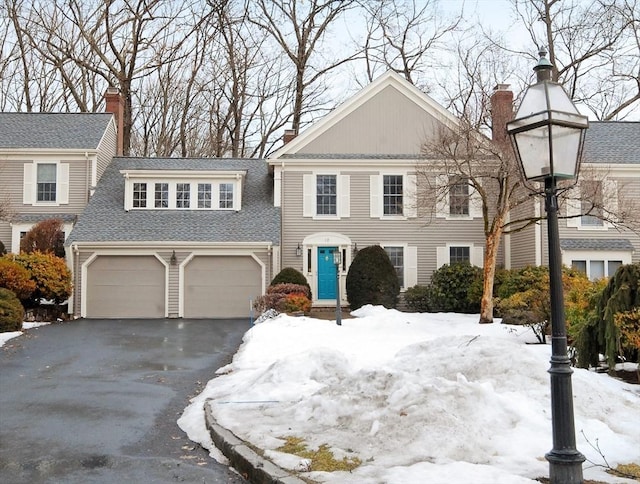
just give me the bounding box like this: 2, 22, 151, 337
66, 157, 280, 318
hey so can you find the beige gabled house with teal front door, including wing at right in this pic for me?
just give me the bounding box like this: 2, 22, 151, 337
267, 72, 640, 306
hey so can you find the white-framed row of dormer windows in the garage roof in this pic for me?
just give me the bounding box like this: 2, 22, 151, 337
121, 170, 246, 211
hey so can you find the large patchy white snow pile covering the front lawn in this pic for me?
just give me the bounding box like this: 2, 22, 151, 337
178, 306, 640, 484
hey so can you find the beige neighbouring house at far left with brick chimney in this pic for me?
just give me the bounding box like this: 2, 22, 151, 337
0, 91, 118, 253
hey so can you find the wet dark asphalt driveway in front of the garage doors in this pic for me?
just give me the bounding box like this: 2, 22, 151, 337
0, 319, 249, 484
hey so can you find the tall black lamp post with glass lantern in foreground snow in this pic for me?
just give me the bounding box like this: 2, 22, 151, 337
507, 49, 589, 484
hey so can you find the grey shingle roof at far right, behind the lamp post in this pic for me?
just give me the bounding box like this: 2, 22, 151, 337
582, 121, 640, 164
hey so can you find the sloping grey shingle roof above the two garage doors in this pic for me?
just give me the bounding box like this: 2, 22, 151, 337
66, 158, 280, 245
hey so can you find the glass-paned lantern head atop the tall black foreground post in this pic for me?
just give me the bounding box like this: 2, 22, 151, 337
507, 49, 589, 181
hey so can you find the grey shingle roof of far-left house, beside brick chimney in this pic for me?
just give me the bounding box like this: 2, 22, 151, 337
0, 113, 113, 150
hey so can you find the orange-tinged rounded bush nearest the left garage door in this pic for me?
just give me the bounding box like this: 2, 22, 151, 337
12, 251, 72, 306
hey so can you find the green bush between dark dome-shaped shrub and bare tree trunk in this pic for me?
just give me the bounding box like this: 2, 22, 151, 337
429, 262, 482, 313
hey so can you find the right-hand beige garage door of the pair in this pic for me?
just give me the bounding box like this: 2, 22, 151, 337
184, 256, 262, 318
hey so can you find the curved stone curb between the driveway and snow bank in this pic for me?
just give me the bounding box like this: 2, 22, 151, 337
204, 401, 307, 484
